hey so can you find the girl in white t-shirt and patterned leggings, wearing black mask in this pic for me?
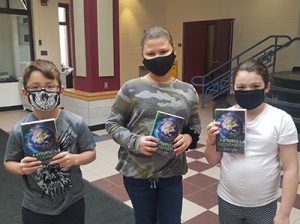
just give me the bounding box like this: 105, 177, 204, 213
205, 60, 298, 224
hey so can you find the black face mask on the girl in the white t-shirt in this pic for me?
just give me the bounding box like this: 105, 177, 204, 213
234, 89, 265, 110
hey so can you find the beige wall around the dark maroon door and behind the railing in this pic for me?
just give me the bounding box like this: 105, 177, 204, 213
164, 0, 300, 75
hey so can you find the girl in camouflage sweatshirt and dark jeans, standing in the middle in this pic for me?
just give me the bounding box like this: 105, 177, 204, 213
106, 27, 200, 224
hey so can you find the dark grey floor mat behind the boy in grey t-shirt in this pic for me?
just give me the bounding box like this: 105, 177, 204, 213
0, 129, 134, 224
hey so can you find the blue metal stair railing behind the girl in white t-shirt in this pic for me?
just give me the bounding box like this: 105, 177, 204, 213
191, 35, 300, 108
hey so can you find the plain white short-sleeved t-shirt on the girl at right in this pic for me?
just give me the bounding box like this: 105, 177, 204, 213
218, 104, 298, 207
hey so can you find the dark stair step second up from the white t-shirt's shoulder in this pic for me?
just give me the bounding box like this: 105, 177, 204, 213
269, 85, 300, 103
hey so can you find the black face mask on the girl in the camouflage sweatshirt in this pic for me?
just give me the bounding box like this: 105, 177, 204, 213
143, 52, 176, 76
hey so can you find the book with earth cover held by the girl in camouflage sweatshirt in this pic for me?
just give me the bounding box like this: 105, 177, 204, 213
151, 111, 184, 155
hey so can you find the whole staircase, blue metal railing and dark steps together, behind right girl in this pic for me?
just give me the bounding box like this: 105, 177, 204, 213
191, 35, 300, 151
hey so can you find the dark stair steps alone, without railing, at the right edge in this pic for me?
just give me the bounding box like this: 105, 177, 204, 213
266, 71, 300, 151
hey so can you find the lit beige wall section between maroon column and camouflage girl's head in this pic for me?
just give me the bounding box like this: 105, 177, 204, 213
119, 0, 165, 84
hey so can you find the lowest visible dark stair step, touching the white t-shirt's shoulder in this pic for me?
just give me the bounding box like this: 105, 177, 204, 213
265, 97, 300, 118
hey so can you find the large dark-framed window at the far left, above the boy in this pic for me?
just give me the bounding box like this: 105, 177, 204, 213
0, 0, 34, 82
